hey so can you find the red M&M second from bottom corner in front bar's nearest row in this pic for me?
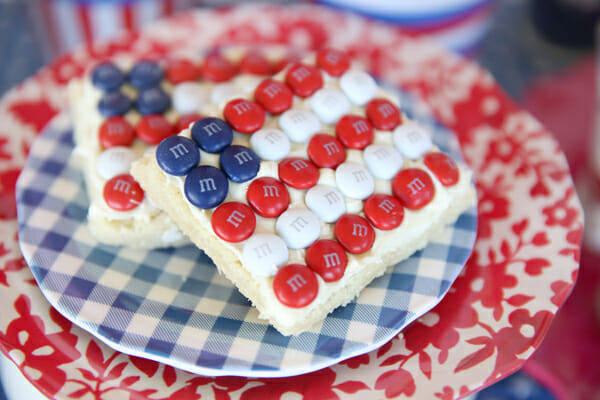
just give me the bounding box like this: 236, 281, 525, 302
306, 239, 348, 282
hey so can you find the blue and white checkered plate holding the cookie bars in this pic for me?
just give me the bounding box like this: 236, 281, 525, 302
17, 88, 477, 377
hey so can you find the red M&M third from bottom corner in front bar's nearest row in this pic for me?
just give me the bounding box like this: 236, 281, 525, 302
334, 214, 375, 254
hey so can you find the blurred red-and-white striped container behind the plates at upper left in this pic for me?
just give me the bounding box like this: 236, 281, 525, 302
27, 0, 196, 61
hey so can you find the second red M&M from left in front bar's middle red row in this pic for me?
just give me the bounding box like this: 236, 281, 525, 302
246, 176, 290, 218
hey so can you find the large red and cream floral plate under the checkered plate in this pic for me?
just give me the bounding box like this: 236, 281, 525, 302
0, 5, 583, 400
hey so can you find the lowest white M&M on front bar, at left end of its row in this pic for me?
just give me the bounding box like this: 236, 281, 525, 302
242, 233, 288, 277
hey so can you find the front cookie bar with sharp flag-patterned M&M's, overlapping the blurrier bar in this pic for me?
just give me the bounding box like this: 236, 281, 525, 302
132, 49, 476, 335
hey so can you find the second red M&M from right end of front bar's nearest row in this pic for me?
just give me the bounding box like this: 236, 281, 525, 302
392, 168, 435, 210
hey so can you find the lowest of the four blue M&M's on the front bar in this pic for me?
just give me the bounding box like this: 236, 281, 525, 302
183, 165, 229, 209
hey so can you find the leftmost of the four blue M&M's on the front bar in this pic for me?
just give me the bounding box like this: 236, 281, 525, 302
156, 136, 200, 176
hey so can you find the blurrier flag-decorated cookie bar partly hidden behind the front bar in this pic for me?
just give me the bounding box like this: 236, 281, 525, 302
69, 48, 292, 248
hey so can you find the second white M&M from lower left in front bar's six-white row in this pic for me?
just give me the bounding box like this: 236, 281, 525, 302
275, 208, 321, 249
